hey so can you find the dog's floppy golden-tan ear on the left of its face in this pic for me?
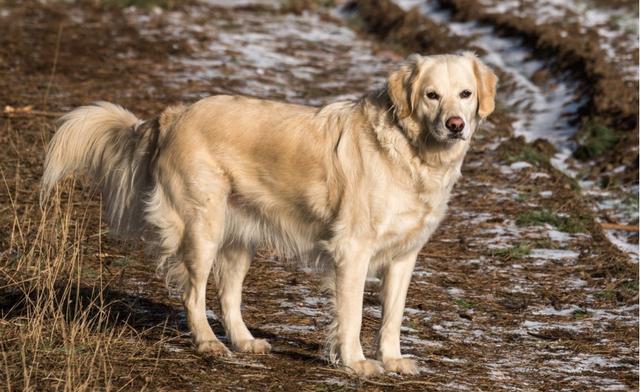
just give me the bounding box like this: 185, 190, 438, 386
387, 54, 422, 119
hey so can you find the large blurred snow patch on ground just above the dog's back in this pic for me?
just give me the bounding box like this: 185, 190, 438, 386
127, 1, 393, 106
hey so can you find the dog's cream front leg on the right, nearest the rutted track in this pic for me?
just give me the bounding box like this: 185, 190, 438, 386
377, 251, 418, 374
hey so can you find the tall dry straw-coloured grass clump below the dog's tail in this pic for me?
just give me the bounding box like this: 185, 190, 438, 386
0, 167, 168, 391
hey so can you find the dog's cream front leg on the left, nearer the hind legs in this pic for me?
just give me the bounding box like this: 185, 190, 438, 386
334, 247, 383, 377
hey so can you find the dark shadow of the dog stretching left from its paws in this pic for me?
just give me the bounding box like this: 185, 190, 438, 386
0, 283, 323, 363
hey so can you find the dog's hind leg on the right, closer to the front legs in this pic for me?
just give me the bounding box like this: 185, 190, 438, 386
214, 244, 271, 354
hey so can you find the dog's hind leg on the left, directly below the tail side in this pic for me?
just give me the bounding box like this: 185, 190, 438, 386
182, 207, 230, 355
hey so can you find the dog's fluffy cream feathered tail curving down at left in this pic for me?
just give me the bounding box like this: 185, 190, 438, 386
40, 102, 159, 234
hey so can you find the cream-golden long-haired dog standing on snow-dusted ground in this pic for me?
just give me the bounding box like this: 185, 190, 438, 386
41, 52, 497, 377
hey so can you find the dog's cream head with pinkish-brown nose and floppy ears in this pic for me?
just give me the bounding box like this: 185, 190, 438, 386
387, 52, 498, 148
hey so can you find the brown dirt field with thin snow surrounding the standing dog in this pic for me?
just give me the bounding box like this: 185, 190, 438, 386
0, 0, 639, 391
